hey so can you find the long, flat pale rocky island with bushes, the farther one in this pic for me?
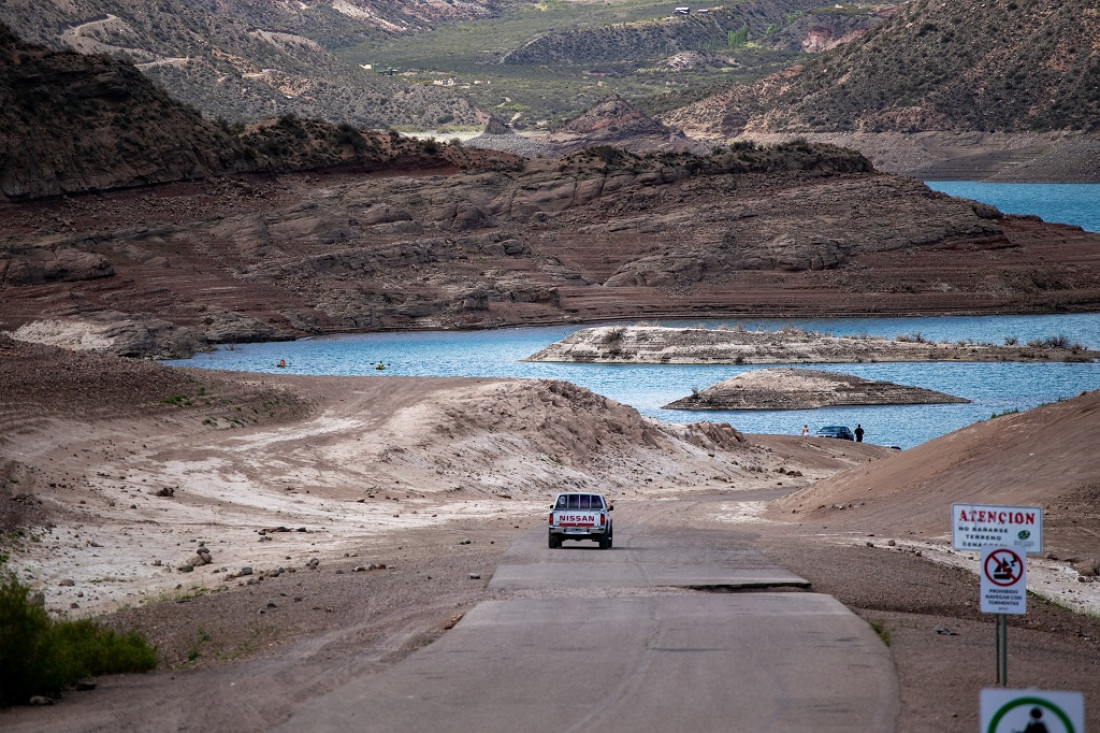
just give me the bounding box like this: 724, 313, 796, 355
527, 325, 1100, 364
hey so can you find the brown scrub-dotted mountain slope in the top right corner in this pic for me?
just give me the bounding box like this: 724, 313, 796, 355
662, 0, 1100, 136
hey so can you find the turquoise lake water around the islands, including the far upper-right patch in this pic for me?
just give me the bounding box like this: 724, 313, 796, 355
165, 182, 1100, 448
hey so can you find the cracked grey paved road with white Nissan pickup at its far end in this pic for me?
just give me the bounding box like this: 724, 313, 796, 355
272, 526, 899, 733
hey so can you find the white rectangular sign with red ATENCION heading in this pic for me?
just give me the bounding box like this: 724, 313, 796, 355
952, 504, 1043, 555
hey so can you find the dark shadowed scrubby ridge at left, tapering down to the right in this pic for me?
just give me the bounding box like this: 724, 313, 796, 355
0, 24, 495, 200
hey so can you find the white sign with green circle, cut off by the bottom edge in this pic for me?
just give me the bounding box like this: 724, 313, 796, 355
981, 688, 1085, 733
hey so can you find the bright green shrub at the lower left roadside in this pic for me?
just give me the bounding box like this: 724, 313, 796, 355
0, 573, 156, 707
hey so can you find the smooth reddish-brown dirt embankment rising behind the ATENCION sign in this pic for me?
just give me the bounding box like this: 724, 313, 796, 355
774, 391, 1100, 561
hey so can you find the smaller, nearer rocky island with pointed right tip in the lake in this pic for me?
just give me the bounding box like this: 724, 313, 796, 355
664, 368, 970, 409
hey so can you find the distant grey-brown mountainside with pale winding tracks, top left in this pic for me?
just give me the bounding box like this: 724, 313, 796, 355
0, 0, 492, 127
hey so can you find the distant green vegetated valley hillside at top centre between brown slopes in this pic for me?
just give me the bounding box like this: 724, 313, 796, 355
338, 0, 817, 127
